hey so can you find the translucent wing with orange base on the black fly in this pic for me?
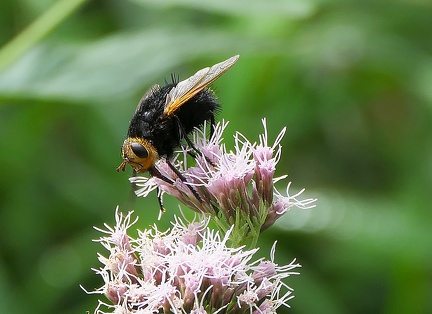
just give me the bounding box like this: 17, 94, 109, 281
164, 55, 239, 115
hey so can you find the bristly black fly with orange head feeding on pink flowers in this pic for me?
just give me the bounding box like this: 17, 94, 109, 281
117, 55, 239, 210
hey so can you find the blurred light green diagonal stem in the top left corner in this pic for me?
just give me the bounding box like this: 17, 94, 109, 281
0, 0, 86, 71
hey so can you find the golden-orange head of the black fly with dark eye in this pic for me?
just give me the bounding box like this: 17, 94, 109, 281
117, 137, 159, 173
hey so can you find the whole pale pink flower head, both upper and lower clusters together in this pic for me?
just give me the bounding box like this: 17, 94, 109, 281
90, 120, 315, 314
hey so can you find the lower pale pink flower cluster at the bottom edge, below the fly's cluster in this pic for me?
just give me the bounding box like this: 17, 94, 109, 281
84, 211, 300, 314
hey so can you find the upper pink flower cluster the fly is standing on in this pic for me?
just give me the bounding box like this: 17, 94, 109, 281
131, 119, 315, 247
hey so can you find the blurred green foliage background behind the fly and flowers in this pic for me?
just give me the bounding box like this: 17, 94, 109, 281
0, 0, 432, 314
